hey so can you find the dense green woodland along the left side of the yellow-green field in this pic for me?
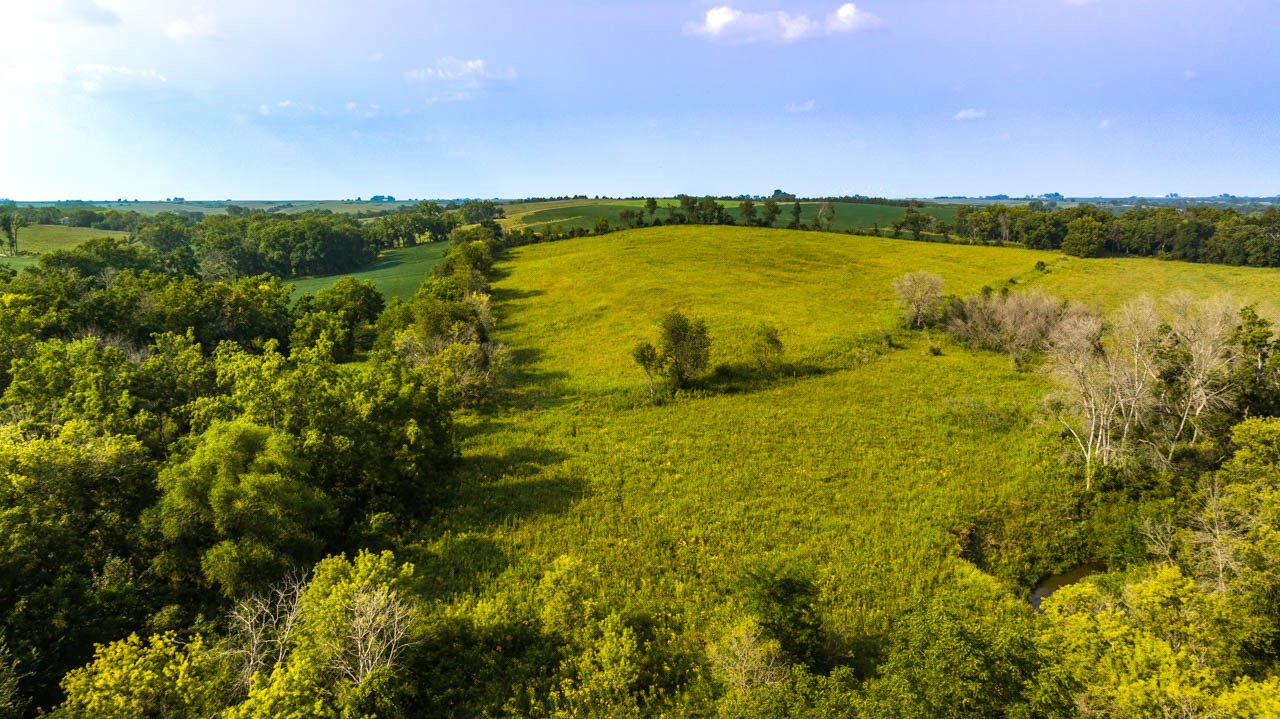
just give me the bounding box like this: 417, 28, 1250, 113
0, 216, 504, 716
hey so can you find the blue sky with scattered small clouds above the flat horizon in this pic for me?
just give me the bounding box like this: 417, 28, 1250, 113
0, 0, 1280, 201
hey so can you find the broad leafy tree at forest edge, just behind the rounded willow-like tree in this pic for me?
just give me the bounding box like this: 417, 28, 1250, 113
192, 344, 453, 531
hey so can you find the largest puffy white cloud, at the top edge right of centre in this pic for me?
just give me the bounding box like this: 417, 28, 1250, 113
685, 3, 881, 42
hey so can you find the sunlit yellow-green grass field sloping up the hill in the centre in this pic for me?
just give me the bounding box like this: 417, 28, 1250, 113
408, 226, 1280, 680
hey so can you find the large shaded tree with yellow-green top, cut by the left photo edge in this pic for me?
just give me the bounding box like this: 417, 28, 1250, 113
0, 420, 156, 705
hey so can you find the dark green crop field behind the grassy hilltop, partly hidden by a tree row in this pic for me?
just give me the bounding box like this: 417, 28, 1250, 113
507, 200, 956, 234
